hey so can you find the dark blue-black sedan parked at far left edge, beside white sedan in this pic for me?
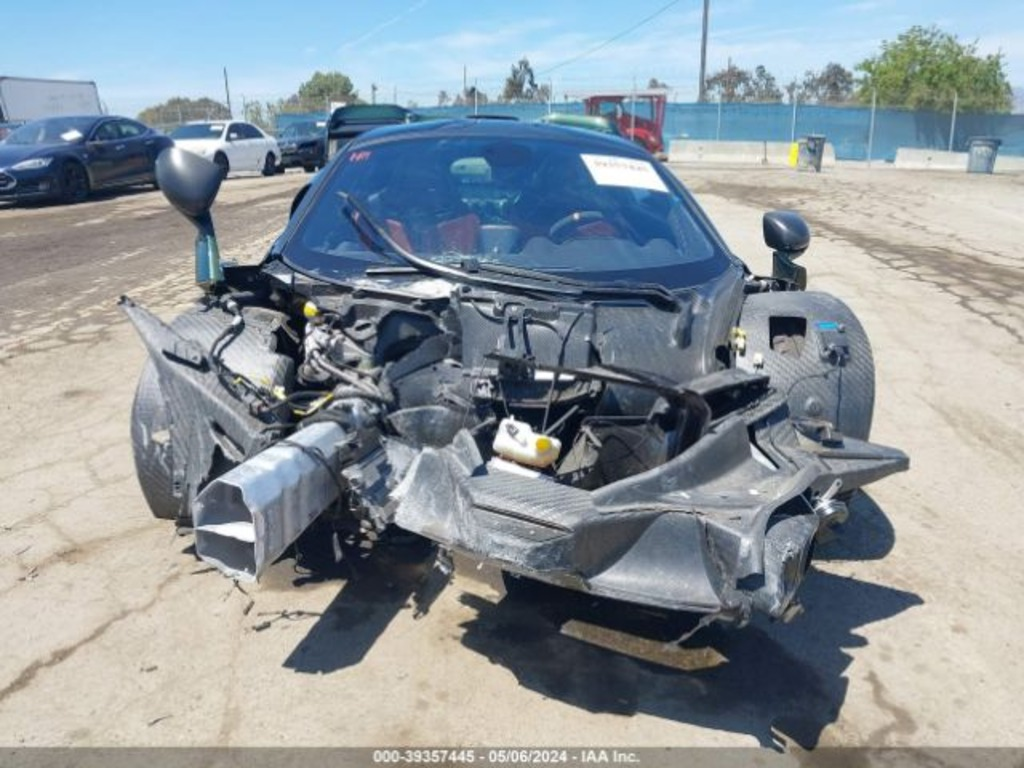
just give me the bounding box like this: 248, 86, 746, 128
0, 115, 174, 203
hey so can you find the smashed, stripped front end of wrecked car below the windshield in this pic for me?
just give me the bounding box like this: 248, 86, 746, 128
117, 262, 905, 620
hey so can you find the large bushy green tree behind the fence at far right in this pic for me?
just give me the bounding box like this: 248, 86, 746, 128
855, 26, 1013, 112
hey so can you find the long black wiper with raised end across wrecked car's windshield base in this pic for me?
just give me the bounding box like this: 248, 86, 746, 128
338, 190, 679, 309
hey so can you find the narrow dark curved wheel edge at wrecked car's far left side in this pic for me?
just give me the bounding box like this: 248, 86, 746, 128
131, 360, 180, 520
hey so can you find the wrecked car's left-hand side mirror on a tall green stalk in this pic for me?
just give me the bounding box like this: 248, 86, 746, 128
155, 146, 224, 290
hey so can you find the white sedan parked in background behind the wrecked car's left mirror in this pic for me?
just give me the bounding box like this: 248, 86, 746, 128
170, 120, 281, 176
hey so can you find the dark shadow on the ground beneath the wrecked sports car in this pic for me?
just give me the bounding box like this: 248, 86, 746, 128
276, 497, 923, 749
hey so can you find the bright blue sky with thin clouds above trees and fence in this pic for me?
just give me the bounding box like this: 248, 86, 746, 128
0, 0, 1024, 115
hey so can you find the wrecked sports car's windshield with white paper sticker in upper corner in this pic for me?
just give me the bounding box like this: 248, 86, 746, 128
284, 129, 729, 288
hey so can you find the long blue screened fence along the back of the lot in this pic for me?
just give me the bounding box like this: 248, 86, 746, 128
278, 102, 1024, 162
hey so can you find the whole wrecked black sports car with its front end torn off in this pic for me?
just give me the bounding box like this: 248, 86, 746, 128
122, 120, 908, 624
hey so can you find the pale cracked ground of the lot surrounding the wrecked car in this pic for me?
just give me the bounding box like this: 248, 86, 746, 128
0, 167, 1024, 746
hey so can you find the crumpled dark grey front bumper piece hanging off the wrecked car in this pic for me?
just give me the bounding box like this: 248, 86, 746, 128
392, 420, 907, 623
